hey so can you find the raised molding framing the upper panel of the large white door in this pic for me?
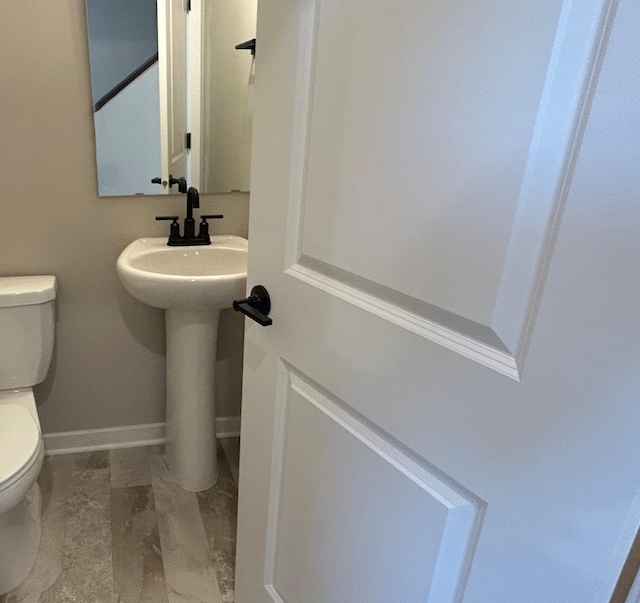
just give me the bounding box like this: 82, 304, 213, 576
285, 0, 617, 381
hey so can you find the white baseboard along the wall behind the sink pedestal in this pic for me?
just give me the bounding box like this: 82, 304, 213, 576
44, 416, 240, 456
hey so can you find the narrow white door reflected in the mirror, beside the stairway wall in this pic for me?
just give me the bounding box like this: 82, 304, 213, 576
158, 0, 187, 193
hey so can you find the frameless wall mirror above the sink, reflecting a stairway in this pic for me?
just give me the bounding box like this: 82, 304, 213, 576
86, 0, 257, 196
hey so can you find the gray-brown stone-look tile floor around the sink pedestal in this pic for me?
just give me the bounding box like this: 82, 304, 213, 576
0, 439, 239, 603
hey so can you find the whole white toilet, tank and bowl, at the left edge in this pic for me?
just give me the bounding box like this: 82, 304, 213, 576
0, 276, 56, 596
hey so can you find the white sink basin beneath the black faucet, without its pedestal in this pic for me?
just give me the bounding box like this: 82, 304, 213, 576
116, 235, 248, 309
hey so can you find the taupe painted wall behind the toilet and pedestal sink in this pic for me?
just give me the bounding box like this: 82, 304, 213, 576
0, 0, 248, 433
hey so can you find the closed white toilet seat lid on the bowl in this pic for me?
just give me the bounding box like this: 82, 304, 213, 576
0, 404, 40, 486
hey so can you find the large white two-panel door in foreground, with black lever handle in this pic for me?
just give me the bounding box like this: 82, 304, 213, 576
236, 0, 640, 603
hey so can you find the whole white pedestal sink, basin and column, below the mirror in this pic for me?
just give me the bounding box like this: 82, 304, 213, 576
117, 236, 248, 491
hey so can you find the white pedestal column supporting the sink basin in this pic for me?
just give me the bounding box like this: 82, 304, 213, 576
165, 308, 220, 491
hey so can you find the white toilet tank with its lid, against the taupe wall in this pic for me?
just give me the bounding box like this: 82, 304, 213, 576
0, 276, 57, 390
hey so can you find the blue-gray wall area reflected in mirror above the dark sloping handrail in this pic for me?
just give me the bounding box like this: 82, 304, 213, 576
87, 0, 158, 103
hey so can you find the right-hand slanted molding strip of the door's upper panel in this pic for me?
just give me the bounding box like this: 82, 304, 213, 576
491, 0, 618, 370
